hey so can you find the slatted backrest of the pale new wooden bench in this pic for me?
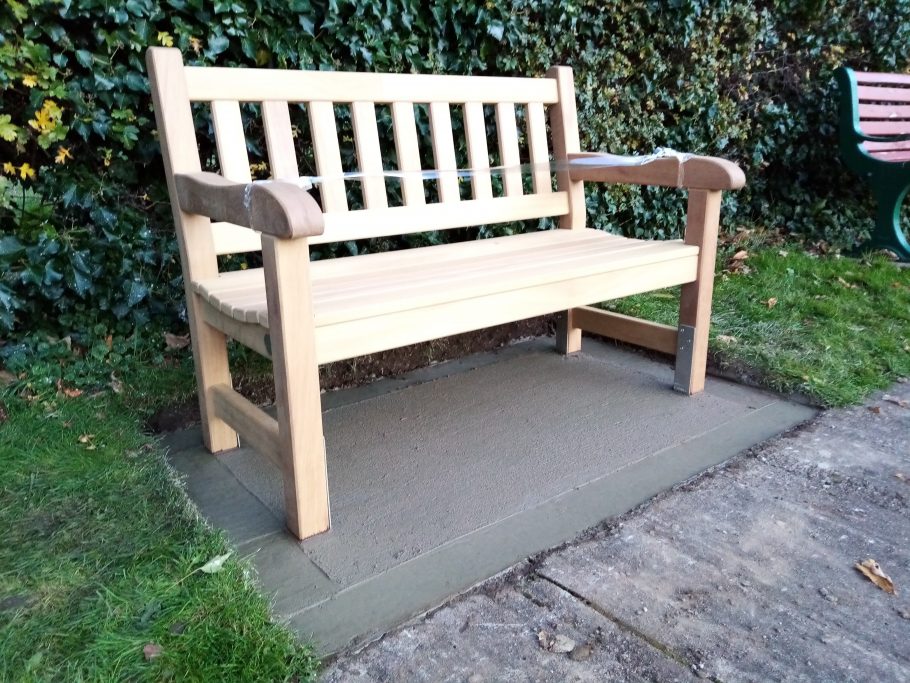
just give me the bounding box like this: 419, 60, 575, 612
149, 48, 584, 254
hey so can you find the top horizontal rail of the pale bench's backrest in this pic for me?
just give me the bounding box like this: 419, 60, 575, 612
184, 67, 558, 104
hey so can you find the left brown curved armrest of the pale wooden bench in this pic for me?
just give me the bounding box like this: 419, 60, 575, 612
174, 171, 325, 238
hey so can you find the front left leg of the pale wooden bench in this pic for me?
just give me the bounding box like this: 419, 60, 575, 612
262, 235, 331, 538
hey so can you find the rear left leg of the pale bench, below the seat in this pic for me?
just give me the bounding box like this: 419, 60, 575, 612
187, 292, 237, 453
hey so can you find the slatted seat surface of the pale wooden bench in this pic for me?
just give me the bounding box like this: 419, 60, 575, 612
196, 230, 698, 327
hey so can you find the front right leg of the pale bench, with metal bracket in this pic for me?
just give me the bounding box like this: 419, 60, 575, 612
673, 190, 721, 394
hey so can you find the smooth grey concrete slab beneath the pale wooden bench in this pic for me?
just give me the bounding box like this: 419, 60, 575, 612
166, 340, 814, 652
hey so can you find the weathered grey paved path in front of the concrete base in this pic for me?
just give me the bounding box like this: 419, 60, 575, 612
326, 383, 910, 683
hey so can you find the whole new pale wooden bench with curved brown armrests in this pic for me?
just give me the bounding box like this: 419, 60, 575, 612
147, 48, 744, 538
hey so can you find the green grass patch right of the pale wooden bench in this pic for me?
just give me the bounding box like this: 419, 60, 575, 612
609, 245, 910, 406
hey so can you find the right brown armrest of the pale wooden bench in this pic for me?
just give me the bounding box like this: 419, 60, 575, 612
568, 152, 746, 190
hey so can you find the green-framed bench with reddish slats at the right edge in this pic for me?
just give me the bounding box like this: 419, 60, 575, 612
835, 67, 910, 261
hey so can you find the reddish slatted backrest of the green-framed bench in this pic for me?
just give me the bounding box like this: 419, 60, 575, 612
841, 69, 910, 158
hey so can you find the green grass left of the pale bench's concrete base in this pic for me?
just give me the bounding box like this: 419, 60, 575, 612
0, 354, 318, 681
